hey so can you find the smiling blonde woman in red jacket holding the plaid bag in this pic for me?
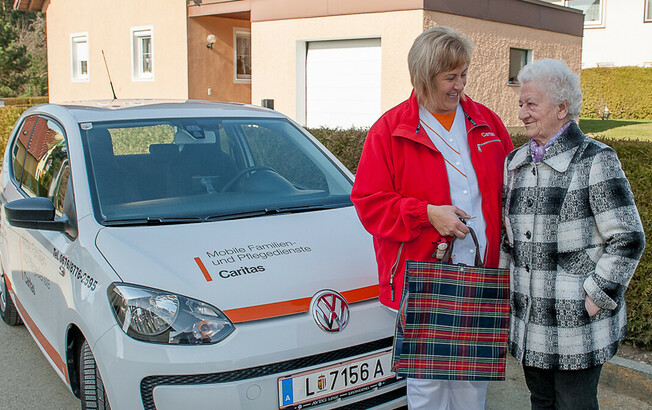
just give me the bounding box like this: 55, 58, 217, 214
351, 26, 513, 409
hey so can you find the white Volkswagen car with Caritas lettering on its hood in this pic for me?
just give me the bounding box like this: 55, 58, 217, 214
0, 100, 405, 410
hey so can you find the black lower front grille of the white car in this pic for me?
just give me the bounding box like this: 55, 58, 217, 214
140, 337, 394, 410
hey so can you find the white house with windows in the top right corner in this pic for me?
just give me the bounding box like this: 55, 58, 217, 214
551, 0, 652, 68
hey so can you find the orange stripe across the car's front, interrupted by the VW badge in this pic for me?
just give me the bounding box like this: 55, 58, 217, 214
224, 285, 378, 323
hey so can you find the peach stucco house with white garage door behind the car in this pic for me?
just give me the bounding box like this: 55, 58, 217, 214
14, 0, 583, 128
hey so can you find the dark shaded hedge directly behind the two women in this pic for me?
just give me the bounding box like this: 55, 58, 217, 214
309, 128, 652, 350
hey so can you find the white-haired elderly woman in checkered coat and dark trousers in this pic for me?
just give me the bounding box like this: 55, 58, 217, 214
501, 59, 645, 409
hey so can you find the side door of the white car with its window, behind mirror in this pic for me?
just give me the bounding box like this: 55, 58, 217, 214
14, 116, 75, 352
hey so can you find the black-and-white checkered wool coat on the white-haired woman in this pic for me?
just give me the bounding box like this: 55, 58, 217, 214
501, 122, 645, 370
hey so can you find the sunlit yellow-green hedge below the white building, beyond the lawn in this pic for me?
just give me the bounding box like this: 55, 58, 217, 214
581, 67, 652, 120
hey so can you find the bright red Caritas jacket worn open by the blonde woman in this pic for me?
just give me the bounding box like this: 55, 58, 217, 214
351, 92, 514, 309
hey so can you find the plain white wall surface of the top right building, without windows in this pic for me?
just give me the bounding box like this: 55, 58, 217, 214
582, 0, 652, 68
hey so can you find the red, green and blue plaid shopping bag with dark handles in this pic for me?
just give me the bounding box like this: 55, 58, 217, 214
393, 227, 509, 381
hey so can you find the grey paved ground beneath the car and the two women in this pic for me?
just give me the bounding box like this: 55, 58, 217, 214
0, 323, 652, 410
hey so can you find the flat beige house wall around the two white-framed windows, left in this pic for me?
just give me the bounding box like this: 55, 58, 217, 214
46, 0, 188, 102
